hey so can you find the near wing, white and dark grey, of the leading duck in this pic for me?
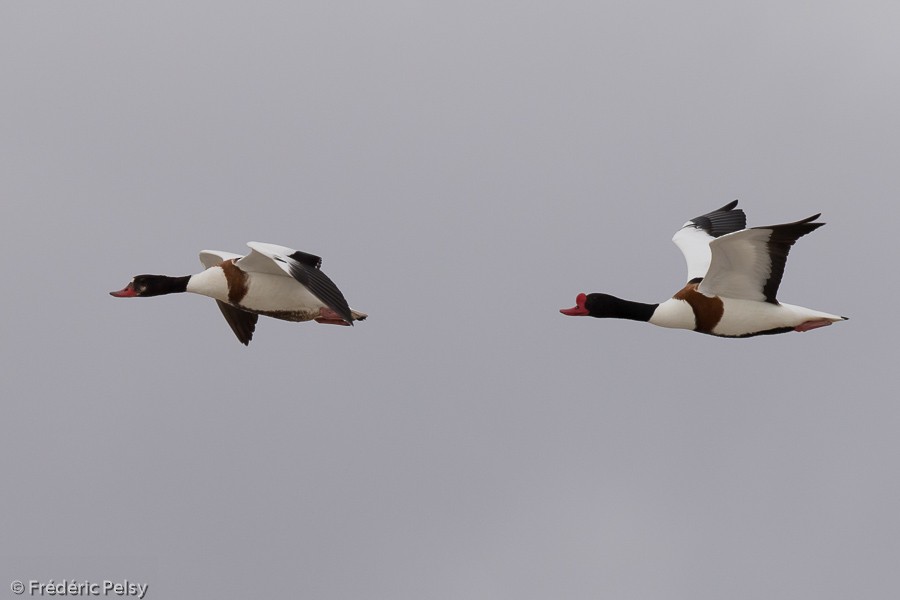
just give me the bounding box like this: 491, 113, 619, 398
235, 242, 353, 325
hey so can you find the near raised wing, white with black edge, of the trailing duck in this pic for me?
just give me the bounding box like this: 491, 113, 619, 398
697, 215, 825, 304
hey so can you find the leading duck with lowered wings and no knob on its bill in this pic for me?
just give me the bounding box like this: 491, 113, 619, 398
110, 242, 368, 346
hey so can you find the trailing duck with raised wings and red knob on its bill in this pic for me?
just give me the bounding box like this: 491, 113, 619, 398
560, 200, 847, 338
